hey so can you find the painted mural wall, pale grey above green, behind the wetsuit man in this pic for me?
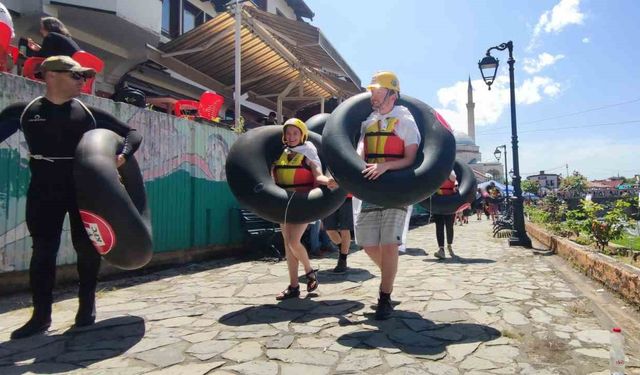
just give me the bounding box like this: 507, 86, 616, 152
0, 73, 242, 272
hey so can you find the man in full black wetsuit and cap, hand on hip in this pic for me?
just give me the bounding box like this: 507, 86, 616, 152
0, 56, 142, 339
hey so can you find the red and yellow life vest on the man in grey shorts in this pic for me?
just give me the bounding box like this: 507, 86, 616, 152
364, 118, 404, 163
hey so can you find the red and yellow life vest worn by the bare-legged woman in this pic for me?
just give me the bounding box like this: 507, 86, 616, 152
273, 151, 316, 192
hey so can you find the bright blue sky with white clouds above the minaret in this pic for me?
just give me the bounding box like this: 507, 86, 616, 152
305, 0, 640, 179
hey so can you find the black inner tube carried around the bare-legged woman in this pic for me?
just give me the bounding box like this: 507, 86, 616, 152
225, 125, 346, 223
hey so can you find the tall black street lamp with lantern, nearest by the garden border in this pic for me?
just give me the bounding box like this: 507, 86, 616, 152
478, 41, 531, 247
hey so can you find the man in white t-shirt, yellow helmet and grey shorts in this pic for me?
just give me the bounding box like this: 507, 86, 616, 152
355, 72, 420, 320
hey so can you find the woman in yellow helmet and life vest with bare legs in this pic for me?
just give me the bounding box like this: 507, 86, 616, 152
271, 118, 337, 301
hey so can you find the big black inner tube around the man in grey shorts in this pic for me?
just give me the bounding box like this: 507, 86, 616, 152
322, 93, 456, 207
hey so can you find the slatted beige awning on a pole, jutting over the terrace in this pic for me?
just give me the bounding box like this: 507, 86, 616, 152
147, 6, 361, 115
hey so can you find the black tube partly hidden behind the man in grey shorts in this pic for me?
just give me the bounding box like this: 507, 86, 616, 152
420, 160, 478, 215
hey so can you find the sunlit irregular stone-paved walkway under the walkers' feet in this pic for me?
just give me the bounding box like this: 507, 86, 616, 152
0, 219, 640, 375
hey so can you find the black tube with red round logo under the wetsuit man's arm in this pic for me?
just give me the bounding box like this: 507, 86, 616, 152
73, 129, 153, 270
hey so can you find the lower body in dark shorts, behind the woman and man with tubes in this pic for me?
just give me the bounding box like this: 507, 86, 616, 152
322, 194, 353, 273
